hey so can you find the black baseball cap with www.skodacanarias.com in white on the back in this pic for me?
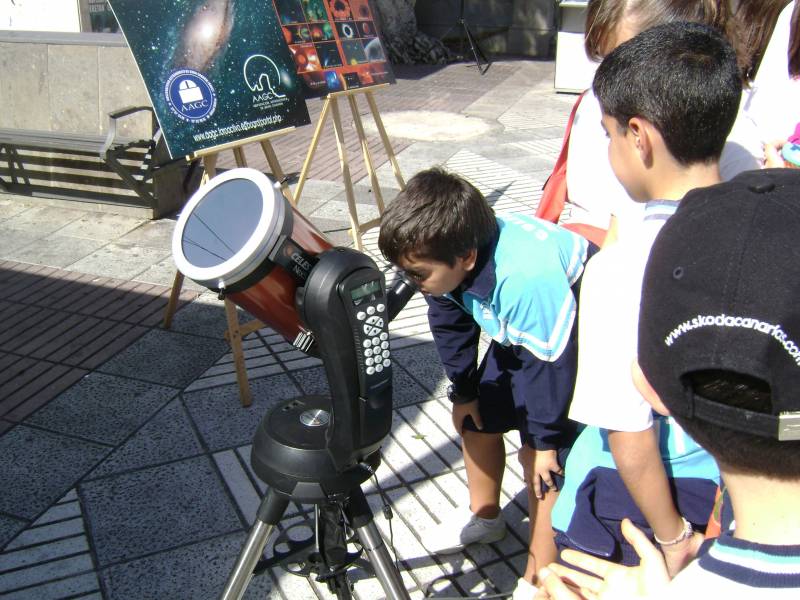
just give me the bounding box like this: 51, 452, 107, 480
638, 169, 800, 440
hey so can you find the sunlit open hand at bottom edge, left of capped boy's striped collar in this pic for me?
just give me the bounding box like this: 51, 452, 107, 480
537, 519, 670, 600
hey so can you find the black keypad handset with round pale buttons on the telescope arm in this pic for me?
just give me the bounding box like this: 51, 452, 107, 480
344, 271, 392, 397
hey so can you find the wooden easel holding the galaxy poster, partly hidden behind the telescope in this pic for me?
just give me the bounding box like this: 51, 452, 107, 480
164, 127, 295, 406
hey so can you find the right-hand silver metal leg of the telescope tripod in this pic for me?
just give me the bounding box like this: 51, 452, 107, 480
346, 487, 410, 600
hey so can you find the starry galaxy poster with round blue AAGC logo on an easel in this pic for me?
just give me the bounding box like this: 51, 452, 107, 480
109, 0, 306, 157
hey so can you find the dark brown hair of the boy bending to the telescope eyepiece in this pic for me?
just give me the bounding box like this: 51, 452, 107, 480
378, 168, 497, 266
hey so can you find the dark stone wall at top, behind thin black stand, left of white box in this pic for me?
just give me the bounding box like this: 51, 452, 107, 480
415, 0, 557, 58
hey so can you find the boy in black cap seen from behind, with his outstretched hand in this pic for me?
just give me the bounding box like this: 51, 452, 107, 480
540, 169, 800, 600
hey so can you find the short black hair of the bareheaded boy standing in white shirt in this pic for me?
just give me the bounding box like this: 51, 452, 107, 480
593, 22, 742, 165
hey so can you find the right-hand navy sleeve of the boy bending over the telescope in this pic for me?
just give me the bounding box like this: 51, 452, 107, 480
513, 336, 578, 450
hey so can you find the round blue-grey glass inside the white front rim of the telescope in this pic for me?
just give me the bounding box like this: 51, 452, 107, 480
181, 179, 264, 267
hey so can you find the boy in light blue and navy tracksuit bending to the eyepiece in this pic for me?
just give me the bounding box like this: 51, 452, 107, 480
378, 169, 595, 583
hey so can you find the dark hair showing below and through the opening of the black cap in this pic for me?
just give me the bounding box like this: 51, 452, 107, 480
662, 370, 800, 479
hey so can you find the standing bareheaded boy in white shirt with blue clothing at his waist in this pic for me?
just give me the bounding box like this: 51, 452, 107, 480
552, 22, 741, 573
